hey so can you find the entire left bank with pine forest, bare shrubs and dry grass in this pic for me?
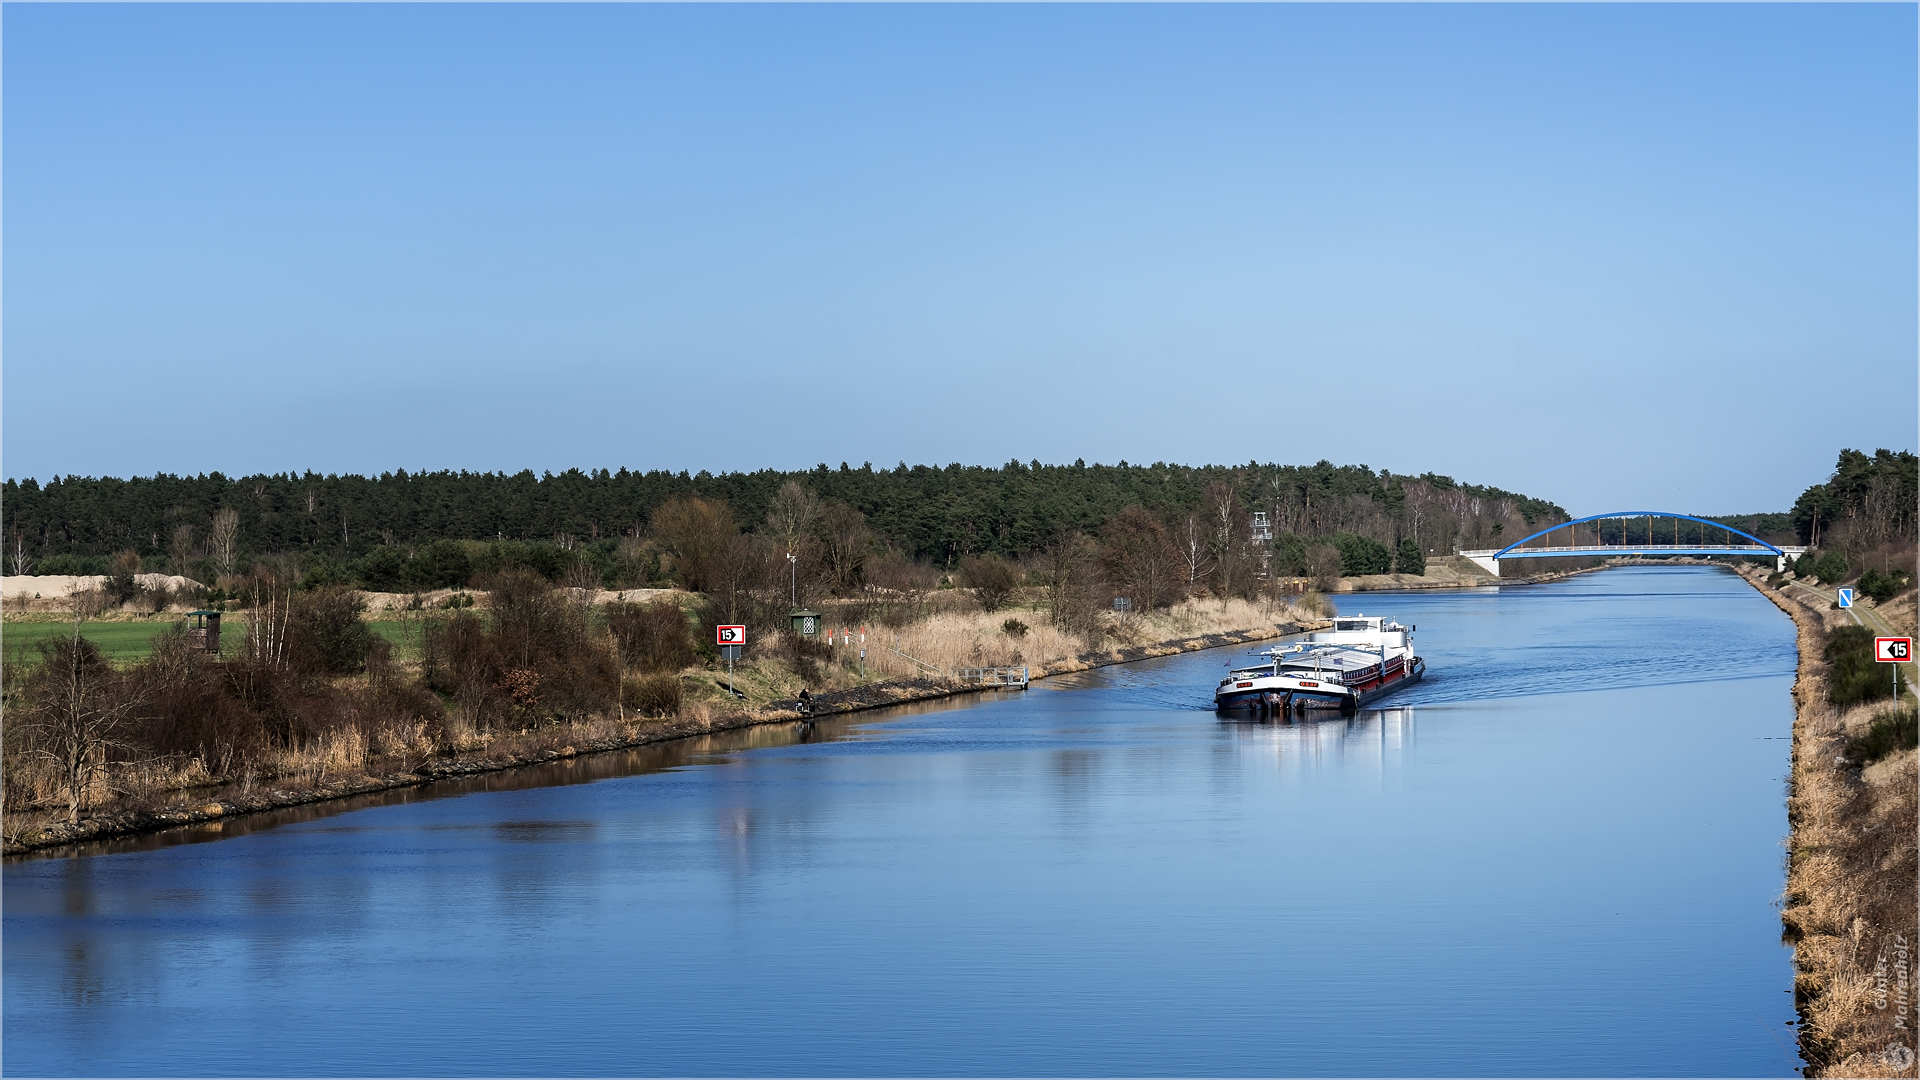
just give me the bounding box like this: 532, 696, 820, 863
0, 461, 1565, 846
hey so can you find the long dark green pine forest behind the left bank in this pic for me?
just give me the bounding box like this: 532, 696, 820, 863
0, 461, 1567, 588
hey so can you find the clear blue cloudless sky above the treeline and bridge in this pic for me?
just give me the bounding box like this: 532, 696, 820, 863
0, 4, 1920, 513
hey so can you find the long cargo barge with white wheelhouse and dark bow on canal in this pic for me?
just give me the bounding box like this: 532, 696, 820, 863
1213, 615, 1427, 715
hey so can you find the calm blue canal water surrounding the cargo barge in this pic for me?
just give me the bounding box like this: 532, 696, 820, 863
0, 567, 1799, 1076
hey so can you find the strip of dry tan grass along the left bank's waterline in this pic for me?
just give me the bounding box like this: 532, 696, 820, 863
4, 594, 1317, 851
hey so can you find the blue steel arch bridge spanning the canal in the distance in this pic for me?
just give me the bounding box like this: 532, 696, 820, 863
1461, 509, 1807, 577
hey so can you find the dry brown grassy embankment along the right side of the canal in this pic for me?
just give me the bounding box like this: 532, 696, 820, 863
1741, 567, 1920, 1076
